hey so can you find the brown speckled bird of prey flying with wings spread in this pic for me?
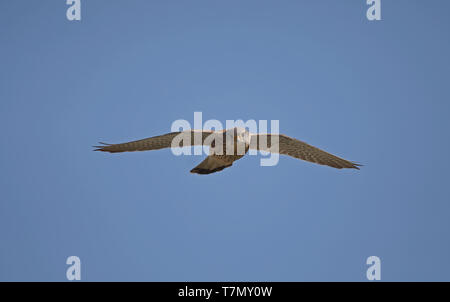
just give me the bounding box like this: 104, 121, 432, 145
94, 128, 361, 174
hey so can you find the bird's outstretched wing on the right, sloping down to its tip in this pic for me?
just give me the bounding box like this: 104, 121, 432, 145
250, 134, 361, 170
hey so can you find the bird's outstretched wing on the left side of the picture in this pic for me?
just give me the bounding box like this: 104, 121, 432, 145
94, 130, 216, 153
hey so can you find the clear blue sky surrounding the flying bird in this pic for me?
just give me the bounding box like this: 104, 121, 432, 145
0, 0, 450, 281
